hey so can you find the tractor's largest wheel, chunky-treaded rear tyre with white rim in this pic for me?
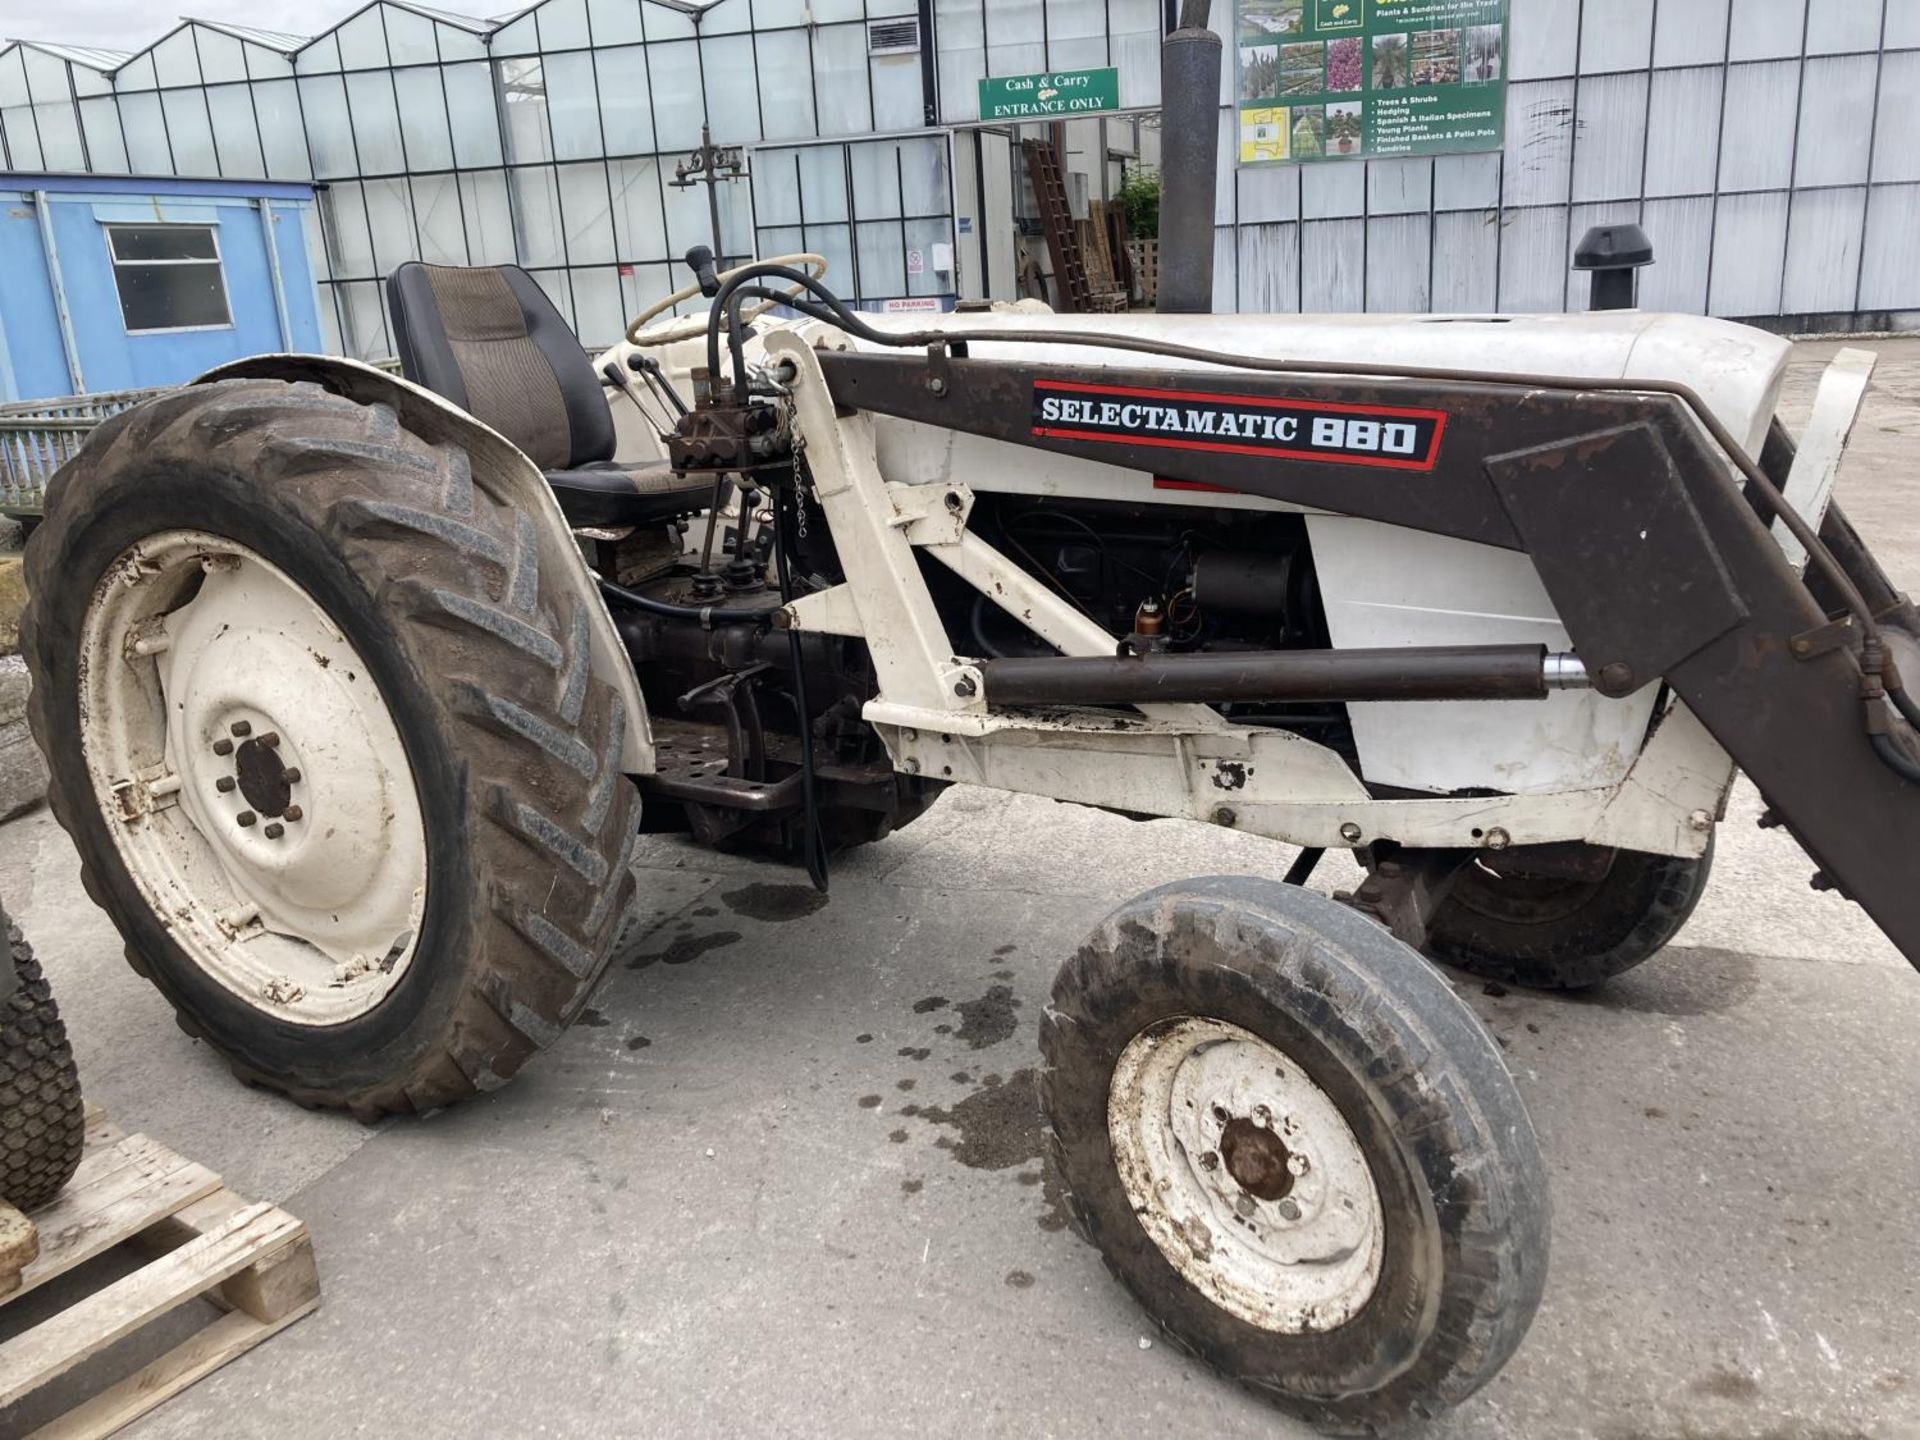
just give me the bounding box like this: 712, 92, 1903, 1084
21, 380, 639, 1117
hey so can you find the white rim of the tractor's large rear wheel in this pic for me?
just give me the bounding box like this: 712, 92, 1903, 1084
79, 530, 426, 1025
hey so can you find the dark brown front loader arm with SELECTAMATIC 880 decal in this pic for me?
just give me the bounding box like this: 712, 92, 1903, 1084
822, 351, 1920, 966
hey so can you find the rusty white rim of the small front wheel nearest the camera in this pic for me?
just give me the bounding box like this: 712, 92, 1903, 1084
1106, 1016, 1386, 1334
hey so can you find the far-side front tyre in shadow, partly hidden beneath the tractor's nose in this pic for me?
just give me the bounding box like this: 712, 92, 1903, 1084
1427, 845, 1713, 991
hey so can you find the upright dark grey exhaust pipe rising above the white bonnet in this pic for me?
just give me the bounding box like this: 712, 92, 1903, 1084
1154, 0, 1221, 315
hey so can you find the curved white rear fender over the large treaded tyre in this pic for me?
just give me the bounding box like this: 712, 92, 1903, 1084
194, 355, 655, 776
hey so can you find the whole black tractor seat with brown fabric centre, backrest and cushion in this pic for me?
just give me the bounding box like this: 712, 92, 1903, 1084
386, 259, 712, 530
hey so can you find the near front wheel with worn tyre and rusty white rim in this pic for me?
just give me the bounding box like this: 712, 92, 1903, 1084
1041, 877, 1548, 1434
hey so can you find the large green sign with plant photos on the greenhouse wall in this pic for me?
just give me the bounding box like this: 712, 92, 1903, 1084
1236, 0, 1507, 165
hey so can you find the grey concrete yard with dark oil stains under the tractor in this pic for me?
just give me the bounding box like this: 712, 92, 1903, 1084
0, 342, 1920, 1440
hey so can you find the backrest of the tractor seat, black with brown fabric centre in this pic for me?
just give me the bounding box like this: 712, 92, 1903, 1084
386, 259, 614, 470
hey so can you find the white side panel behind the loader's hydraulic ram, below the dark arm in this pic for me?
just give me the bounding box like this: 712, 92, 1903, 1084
1308, 515, 1659, 795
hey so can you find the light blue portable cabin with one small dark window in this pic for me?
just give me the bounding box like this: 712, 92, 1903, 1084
0, 173, 324, 403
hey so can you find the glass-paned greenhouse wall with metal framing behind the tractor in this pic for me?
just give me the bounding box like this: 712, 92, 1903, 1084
0, 0, 1920, 355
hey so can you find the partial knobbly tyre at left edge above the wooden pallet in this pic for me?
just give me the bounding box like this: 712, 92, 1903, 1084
0, 908, 86, 1210
